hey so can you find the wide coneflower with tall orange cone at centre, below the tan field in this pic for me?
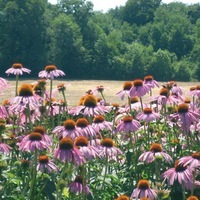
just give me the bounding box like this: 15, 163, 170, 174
69, 94, 108, 117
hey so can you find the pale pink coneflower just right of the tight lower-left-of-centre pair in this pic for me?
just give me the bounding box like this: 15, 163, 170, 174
99, 138, 122, 161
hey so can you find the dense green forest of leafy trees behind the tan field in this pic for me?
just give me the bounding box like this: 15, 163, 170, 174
0, 0, 200, 81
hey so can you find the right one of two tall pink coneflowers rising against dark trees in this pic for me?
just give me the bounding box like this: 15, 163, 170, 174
38, 65, 65, 79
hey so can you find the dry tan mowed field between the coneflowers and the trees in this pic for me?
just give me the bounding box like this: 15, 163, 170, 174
0, 79, 200, 106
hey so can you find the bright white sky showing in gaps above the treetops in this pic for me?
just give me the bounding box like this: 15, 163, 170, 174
48, 0, 200, 12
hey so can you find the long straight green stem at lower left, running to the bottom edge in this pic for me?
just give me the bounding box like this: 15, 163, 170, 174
29, 149, 38, 200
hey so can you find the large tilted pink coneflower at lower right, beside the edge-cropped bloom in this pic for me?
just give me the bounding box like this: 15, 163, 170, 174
161, 160, 194, 189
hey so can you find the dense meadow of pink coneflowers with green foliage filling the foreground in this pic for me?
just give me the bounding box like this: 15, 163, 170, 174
0, 63, 200, 200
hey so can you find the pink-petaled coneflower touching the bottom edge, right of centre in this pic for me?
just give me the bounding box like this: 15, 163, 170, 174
131, 179, 157, 200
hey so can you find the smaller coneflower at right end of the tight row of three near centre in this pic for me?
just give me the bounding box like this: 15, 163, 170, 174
92, 115, 113, 131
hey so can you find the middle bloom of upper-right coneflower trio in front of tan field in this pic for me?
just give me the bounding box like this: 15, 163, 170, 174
129, 79, 151, 98
